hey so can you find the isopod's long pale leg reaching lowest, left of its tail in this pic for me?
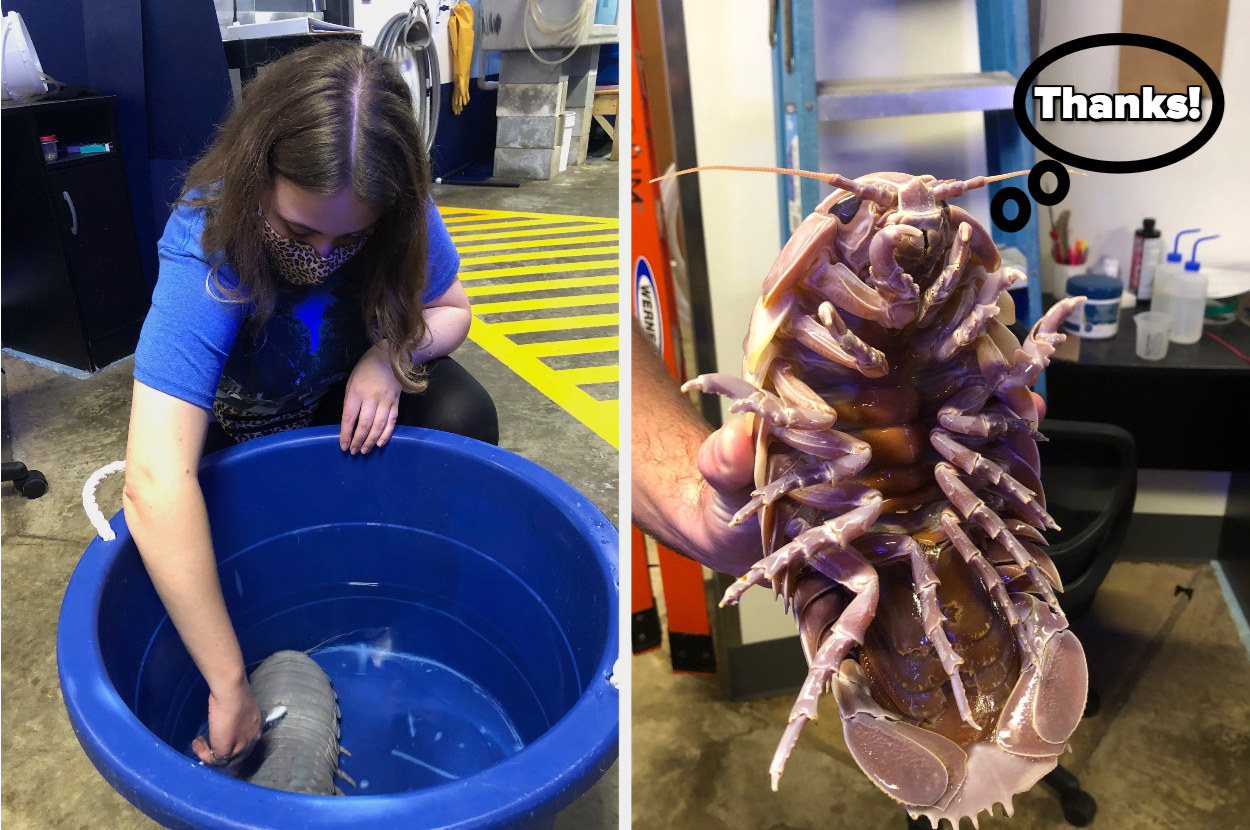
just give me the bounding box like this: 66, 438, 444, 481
769, 545, 880, 791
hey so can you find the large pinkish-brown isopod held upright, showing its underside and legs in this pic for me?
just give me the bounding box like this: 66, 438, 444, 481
691, 170, 1088, 826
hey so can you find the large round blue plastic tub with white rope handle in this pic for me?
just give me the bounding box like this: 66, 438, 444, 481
56, 428, 619, 829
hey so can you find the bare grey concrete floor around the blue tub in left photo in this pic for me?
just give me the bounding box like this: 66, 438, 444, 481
0, 150, 619, 830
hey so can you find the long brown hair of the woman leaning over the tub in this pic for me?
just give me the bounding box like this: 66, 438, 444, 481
180, 41, 430, 391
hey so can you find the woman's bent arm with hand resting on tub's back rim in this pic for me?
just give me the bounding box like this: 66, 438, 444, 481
339, 280, 473, 455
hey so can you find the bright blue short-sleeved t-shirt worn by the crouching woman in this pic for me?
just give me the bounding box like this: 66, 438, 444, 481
135, 203, 460, 415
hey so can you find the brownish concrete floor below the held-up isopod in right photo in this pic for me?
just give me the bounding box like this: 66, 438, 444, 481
631, 561, 1250, 830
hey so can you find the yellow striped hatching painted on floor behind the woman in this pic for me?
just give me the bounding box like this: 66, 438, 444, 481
439, 208, 620, 448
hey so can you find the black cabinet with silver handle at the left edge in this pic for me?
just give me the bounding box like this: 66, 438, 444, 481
0, 96, 150, 371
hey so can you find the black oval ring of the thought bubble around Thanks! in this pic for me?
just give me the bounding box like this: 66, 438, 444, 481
1013, 33, 1224, 173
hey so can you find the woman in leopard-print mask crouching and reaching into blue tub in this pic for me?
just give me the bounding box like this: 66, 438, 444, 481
123, 43, 498, 766
